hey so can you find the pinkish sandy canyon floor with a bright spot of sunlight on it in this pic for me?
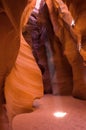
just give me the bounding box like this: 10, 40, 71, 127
13, 95, 86, 130
